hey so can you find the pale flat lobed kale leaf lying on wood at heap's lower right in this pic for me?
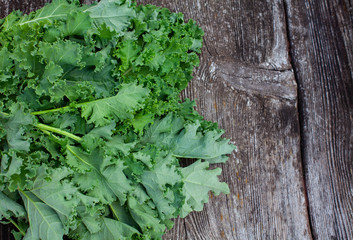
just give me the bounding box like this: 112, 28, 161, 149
180, 160, 229, 218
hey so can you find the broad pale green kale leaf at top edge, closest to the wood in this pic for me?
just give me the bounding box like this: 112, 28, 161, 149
84, 0, 135, 34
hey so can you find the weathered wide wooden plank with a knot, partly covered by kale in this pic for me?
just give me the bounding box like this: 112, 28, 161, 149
0, 0, 311, 240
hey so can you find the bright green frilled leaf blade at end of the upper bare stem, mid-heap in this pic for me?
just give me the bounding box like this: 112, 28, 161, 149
77, 83, 149, 126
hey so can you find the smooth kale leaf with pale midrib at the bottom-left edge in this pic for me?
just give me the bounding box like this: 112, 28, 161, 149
21, 192, 64, 240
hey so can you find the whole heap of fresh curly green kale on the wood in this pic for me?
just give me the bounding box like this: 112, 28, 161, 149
0, 0, 235, 240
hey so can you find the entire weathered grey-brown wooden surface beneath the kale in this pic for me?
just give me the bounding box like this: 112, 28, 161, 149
0, 0, 353, 240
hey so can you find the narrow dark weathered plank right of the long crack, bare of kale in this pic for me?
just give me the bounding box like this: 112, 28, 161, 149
286, 0, 353, 239
